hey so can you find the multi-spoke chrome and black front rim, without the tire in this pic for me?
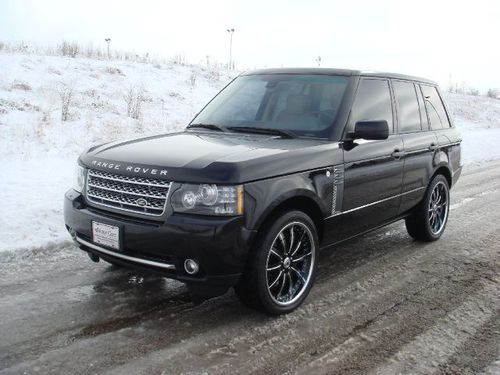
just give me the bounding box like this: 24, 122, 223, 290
266, 222, 315, 306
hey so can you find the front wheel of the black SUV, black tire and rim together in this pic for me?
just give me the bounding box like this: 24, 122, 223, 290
235, 211, 319, 315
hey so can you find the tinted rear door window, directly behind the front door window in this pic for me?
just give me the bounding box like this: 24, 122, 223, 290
392, 81, 422, 133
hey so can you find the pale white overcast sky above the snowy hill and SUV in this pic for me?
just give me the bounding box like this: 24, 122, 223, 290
0, 0, 500, 90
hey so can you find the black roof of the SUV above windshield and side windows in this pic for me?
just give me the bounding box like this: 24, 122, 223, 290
243, 68, 437, 85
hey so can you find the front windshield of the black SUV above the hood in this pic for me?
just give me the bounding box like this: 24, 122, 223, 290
191, 74, 348, 138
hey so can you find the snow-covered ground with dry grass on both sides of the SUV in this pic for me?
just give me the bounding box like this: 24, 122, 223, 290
0, 53, 500, 255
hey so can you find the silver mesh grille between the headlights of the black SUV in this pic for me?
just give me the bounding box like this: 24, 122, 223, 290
86, 169, 171, 216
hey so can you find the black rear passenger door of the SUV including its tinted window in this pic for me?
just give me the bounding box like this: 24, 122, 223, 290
392, 80, 437, 213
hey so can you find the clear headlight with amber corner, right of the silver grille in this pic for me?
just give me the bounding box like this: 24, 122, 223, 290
170, 184, 243, 216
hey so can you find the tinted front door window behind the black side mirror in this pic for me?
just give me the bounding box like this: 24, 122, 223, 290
351, 79, 393, 132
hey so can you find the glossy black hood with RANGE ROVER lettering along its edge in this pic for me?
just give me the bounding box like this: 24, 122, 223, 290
80, 131, 338, 183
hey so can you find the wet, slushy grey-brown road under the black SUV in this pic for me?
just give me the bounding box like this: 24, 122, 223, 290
0, 162, 500, 374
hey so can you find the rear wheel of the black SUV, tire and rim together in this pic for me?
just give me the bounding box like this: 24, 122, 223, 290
406, 174, 450, 242
